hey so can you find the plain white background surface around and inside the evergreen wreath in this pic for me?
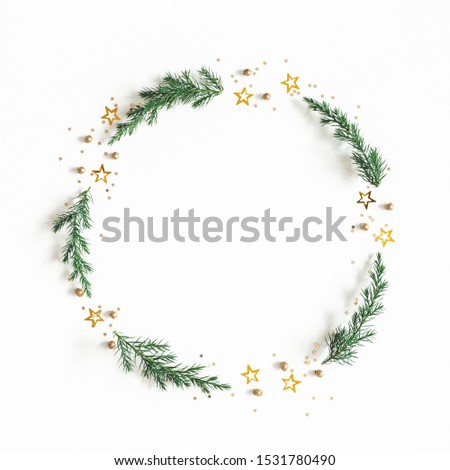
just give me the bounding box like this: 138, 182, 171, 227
0, 0, 450, 468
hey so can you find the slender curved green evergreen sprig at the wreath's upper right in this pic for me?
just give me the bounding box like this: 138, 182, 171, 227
303, 96, 387, 187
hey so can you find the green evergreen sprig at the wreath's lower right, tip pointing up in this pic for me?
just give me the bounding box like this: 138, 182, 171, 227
322, 253, 388, 364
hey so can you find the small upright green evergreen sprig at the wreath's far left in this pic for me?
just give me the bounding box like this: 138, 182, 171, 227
52, 188, 93, 298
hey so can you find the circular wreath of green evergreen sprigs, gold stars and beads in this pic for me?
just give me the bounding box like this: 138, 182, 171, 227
52, 61, 394, 396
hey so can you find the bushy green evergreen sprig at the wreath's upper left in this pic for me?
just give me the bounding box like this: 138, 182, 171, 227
108, 67, 223, 145
